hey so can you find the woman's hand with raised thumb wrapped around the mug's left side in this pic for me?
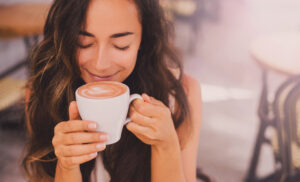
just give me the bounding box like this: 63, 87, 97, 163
52, 101, 107, 170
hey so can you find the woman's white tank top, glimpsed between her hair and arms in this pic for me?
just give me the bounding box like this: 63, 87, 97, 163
91, 69, 179, 182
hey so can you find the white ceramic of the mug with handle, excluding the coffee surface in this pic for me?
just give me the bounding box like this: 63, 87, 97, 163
75, 82, 143, 145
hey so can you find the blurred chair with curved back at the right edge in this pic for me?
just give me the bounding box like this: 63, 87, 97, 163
256, 75, 300, 182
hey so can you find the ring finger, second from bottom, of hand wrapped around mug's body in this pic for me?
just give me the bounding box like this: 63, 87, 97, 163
61, 142, 106, 157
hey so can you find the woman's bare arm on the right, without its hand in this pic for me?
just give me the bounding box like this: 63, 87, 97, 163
151, 75, 201, 182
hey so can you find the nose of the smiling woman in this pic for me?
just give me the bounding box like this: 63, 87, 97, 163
94, 46, 111, 72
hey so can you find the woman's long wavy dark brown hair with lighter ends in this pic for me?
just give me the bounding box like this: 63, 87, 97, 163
22, 0, 190, 182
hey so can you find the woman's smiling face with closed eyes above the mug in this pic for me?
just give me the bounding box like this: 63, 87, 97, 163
77, 0, 142, 83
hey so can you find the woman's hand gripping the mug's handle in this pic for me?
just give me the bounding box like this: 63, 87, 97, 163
126, 94, 178, 148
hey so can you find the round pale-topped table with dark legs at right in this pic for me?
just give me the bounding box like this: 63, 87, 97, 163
245, 32, 300, 182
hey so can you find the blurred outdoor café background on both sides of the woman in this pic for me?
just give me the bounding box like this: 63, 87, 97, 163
0, 0, 300, 182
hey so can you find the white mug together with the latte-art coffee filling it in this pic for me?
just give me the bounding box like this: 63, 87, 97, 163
75, 81, 142, 144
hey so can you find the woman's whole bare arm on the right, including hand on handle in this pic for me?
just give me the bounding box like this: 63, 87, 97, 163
126, 75, 201, 182
